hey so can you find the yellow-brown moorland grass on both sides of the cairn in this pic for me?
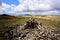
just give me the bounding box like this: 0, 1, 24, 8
0, 16, 60, 40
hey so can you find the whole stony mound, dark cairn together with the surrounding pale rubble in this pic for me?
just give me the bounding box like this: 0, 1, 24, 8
1, 20, 60, 40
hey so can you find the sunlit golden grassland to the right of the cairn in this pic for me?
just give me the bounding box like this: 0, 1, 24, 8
35, 16, 60, 27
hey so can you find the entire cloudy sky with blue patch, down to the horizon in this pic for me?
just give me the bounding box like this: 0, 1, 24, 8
0, 0, 60, 15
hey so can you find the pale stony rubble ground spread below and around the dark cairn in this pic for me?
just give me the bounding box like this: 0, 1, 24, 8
1, 25, 60, 40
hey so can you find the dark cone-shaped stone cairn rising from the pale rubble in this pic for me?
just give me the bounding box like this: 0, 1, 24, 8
25, 18, 39, 28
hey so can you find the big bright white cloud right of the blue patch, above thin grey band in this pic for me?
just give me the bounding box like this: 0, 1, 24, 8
19, 0, 60, 10
